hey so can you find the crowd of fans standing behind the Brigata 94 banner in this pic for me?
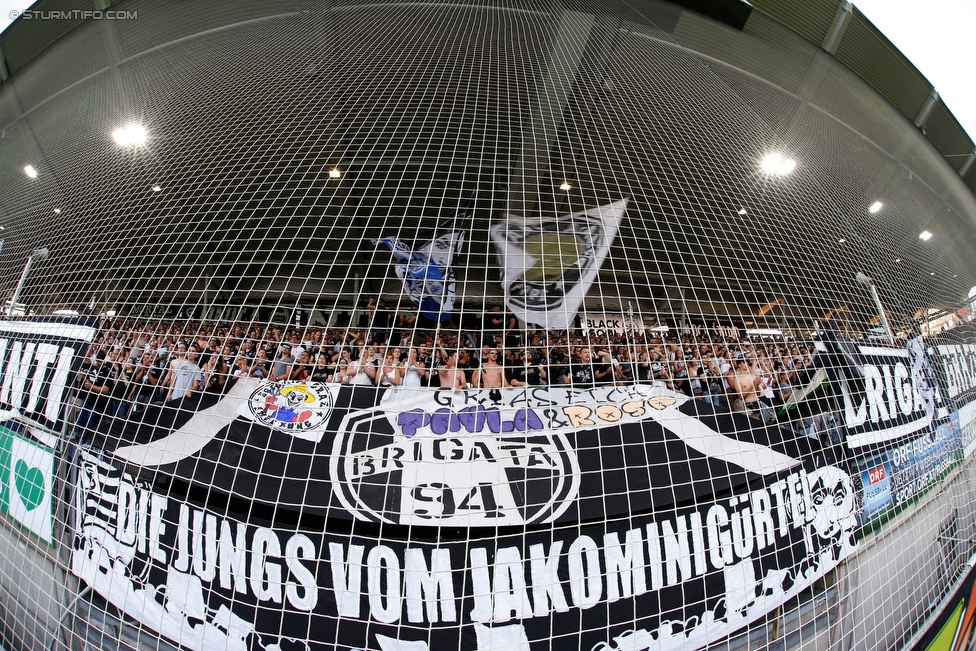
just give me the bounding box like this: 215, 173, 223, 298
79, 299, 814, 427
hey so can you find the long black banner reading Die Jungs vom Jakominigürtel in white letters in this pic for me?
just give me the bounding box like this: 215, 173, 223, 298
72, 454, 856, 651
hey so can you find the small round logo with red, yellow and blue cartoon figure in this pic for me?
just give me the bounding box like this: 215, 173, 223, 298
247, 382, 332, 433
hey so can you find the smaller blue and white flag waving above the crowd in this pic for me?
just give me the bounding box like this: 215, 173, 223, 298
378, 230, 464, 321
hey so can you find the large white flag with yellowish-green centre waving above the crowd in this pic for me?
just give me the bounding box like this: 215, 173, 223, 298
491, 199, 627, 330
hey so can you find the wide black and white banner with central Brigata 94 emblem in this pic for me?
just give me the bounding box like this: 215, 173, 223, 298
97, 379, 817, 527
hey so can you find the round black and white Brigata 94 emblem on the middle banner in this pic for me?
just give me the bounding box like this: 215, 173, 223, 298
331, 411, 579, 527
